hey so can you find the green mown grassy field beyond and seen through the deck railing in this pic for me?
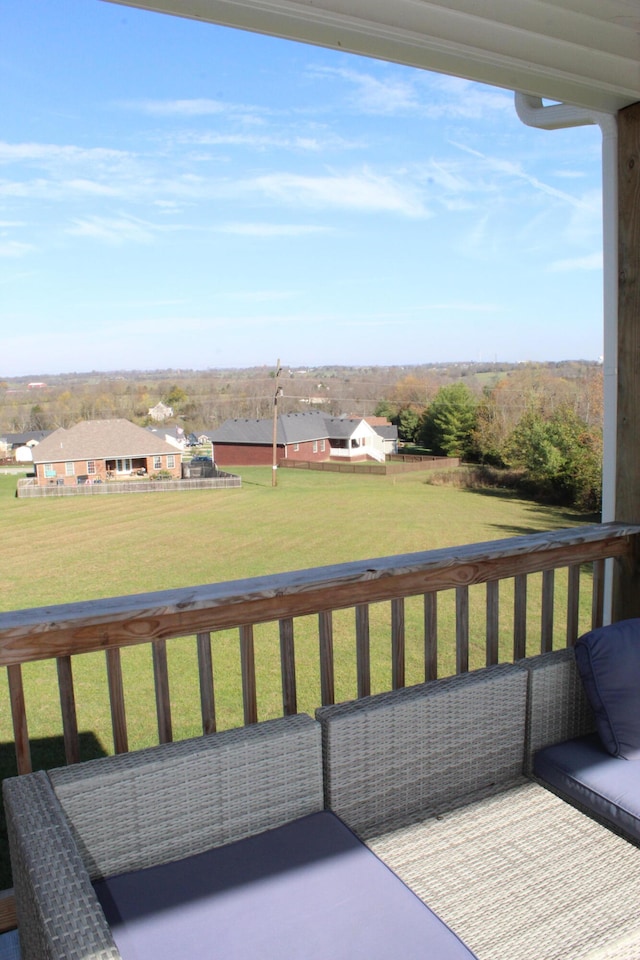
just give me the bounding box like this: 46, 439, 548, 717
0, 468, 593, 888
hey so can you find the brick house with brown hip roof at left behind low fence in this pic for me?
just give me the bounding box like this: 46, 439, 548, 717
33, 420, 182, 484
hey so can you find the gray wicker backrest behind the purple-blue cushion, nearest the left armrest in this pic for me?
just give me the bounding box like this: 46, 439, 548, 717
50, 714, 323, 879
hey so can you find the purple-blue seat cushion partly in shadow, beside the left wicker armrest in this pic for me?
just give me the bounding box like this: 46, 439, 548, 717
95, 811, 474, 960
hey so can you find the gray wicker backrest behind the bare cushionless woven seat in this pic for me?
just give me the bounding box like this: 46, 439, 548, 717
316, 664, 527, 836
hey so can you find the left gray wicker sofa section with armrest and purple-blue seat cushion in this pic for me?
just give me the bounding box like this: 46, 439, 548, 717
4, 715, 474, 960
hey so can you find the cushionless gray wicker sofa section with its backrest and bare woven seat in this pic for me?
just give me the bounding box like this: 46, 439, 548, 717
317, 650, 640, 960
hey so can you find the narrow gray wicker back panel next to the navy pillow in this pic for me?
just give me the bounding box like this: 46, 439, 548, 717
521, 648, 595, 773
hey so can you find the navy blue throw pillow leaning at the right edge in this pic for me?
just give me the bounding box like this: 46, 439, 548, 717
575, 619, 640, 760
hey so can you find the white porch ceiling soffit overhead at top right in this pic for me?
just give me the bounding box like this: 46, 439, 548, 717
104, 0, 640, 111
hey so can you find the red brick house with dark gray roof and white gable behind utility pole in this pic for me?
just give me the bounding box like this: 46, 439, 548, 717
211, 411, 392, 466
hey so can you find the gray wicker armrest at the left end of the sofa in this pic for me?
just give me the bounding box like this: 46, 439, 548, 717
3, 771, 120, 960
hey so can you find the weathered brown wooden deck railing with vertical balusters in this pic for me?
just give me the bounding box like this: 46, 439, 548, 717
0, 524, 640, 773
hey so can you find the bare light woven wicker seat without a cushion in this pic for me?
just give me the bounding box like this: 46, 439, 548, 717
368, 782, 640, 960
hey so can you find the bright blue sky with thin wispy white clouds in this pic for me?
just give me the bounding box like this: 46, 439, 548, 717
0, 0, 602, 377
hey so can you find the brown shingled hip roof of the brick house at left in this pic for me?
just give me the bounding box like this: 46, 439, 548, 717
33, 420, 181, 463
